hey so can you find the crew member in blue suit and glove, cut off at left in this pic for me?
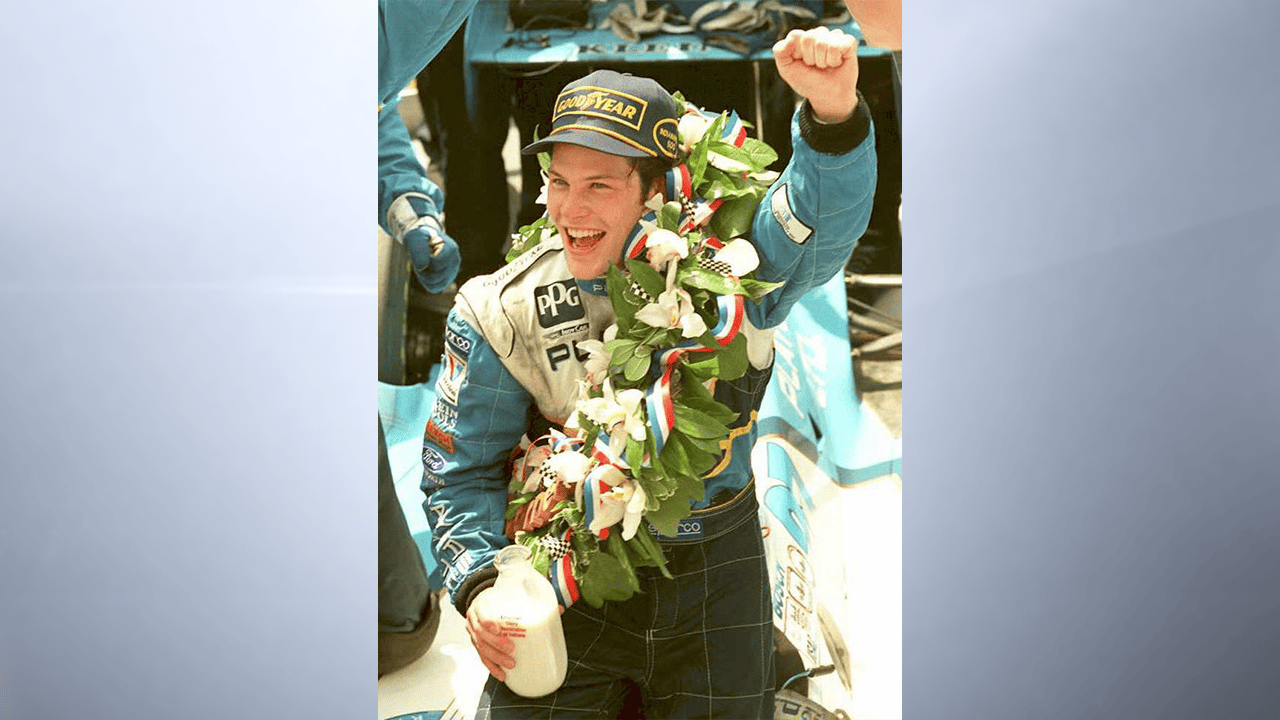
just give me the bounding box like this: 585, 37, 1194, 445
378, 0, 476, 676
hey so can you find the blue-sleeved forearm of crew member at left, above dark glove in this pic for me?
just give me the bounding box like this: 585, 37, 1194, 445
378, 100, 444, 230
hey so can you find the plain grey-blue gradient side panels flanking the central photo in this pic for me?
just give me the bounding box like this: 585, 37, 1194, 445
0, 0, 1280, 720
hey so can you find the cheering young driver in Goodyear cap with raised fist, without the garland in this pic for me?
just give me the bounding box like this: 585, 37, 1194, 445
422, 28, 876, 719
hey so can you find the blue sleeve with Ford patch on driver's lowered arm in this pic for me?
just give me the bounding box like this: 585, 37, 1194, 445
422, 311, 532, 615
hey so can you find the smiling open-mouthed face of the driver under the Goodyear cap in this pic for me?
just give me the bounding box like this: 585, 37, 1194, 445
547, 142, 652, 279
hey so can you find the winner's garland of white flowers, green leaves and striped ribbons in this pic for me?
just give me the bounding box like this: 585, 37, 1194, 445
496, 92, 782, 607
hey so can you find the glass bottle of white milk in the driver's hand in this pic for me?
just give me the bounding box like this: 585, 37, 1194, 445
475, 543, 568, 697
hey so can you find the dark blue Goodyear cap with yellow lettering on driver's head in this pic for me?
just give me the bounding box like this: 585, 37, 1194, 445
521, 70, 680, 160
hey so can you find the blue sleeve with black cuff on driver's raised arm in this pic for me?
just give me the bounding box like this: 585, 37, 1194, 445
746, 100, 876, 328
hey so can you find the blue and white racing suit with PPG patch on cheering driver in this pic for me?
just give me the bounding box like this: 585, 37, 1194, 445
422, 101, 876, 717
